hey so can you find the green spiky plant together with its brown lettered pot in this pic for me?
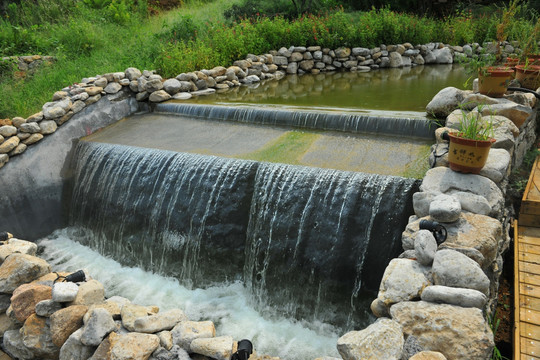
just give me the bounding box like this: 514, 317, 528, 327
448, 107, 495, 174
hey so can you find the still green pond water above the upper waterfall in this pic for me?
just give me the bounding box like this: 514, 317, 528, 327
189, 65, 469, 115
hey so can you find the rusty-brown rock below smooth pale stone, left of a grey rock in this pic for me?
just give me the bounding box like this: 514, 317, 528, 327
50, 305, 88, 347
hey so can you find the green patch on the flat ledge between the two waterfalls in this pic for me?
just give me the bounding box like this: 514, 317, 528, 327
241, 130, 320, 165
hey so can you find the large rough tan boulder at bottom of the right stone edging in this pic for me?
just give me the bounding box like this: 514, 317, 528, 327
390, 301, 494, 360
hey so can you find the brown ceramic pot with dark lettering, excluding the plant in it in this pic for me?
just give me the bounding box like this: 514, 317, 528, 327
448, 134, 495, 174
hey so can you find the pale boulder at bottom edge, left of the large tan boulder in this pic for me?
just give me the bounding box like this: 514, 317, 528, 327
337, 318, 405, 360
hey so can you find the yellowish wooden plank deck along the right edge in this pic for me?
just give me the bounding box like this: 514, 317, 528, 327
514, 157, 540, 360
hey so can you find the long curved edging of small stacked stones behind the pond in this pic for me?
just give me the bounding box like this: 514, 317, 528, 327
0, 42, 519, 168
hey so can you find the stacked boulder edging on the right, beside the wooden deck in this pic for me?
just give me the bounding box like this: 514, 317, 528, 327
338, 88, 537, 360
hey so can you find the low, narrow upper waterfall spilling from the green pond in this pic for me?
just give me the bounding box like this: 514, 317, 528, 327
154, 103, 435, 139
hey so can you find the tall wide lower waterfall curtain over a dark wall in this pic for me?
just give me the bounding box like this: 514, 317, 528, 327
70, 142, 418, 325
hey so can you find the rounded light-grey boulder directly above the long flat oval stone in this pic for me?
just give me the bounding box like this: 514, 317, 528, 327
433, 249, 490, 295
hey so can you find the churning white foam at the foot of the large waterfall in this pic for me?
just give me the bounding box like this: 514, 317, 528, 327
39, 229, 340, 360
